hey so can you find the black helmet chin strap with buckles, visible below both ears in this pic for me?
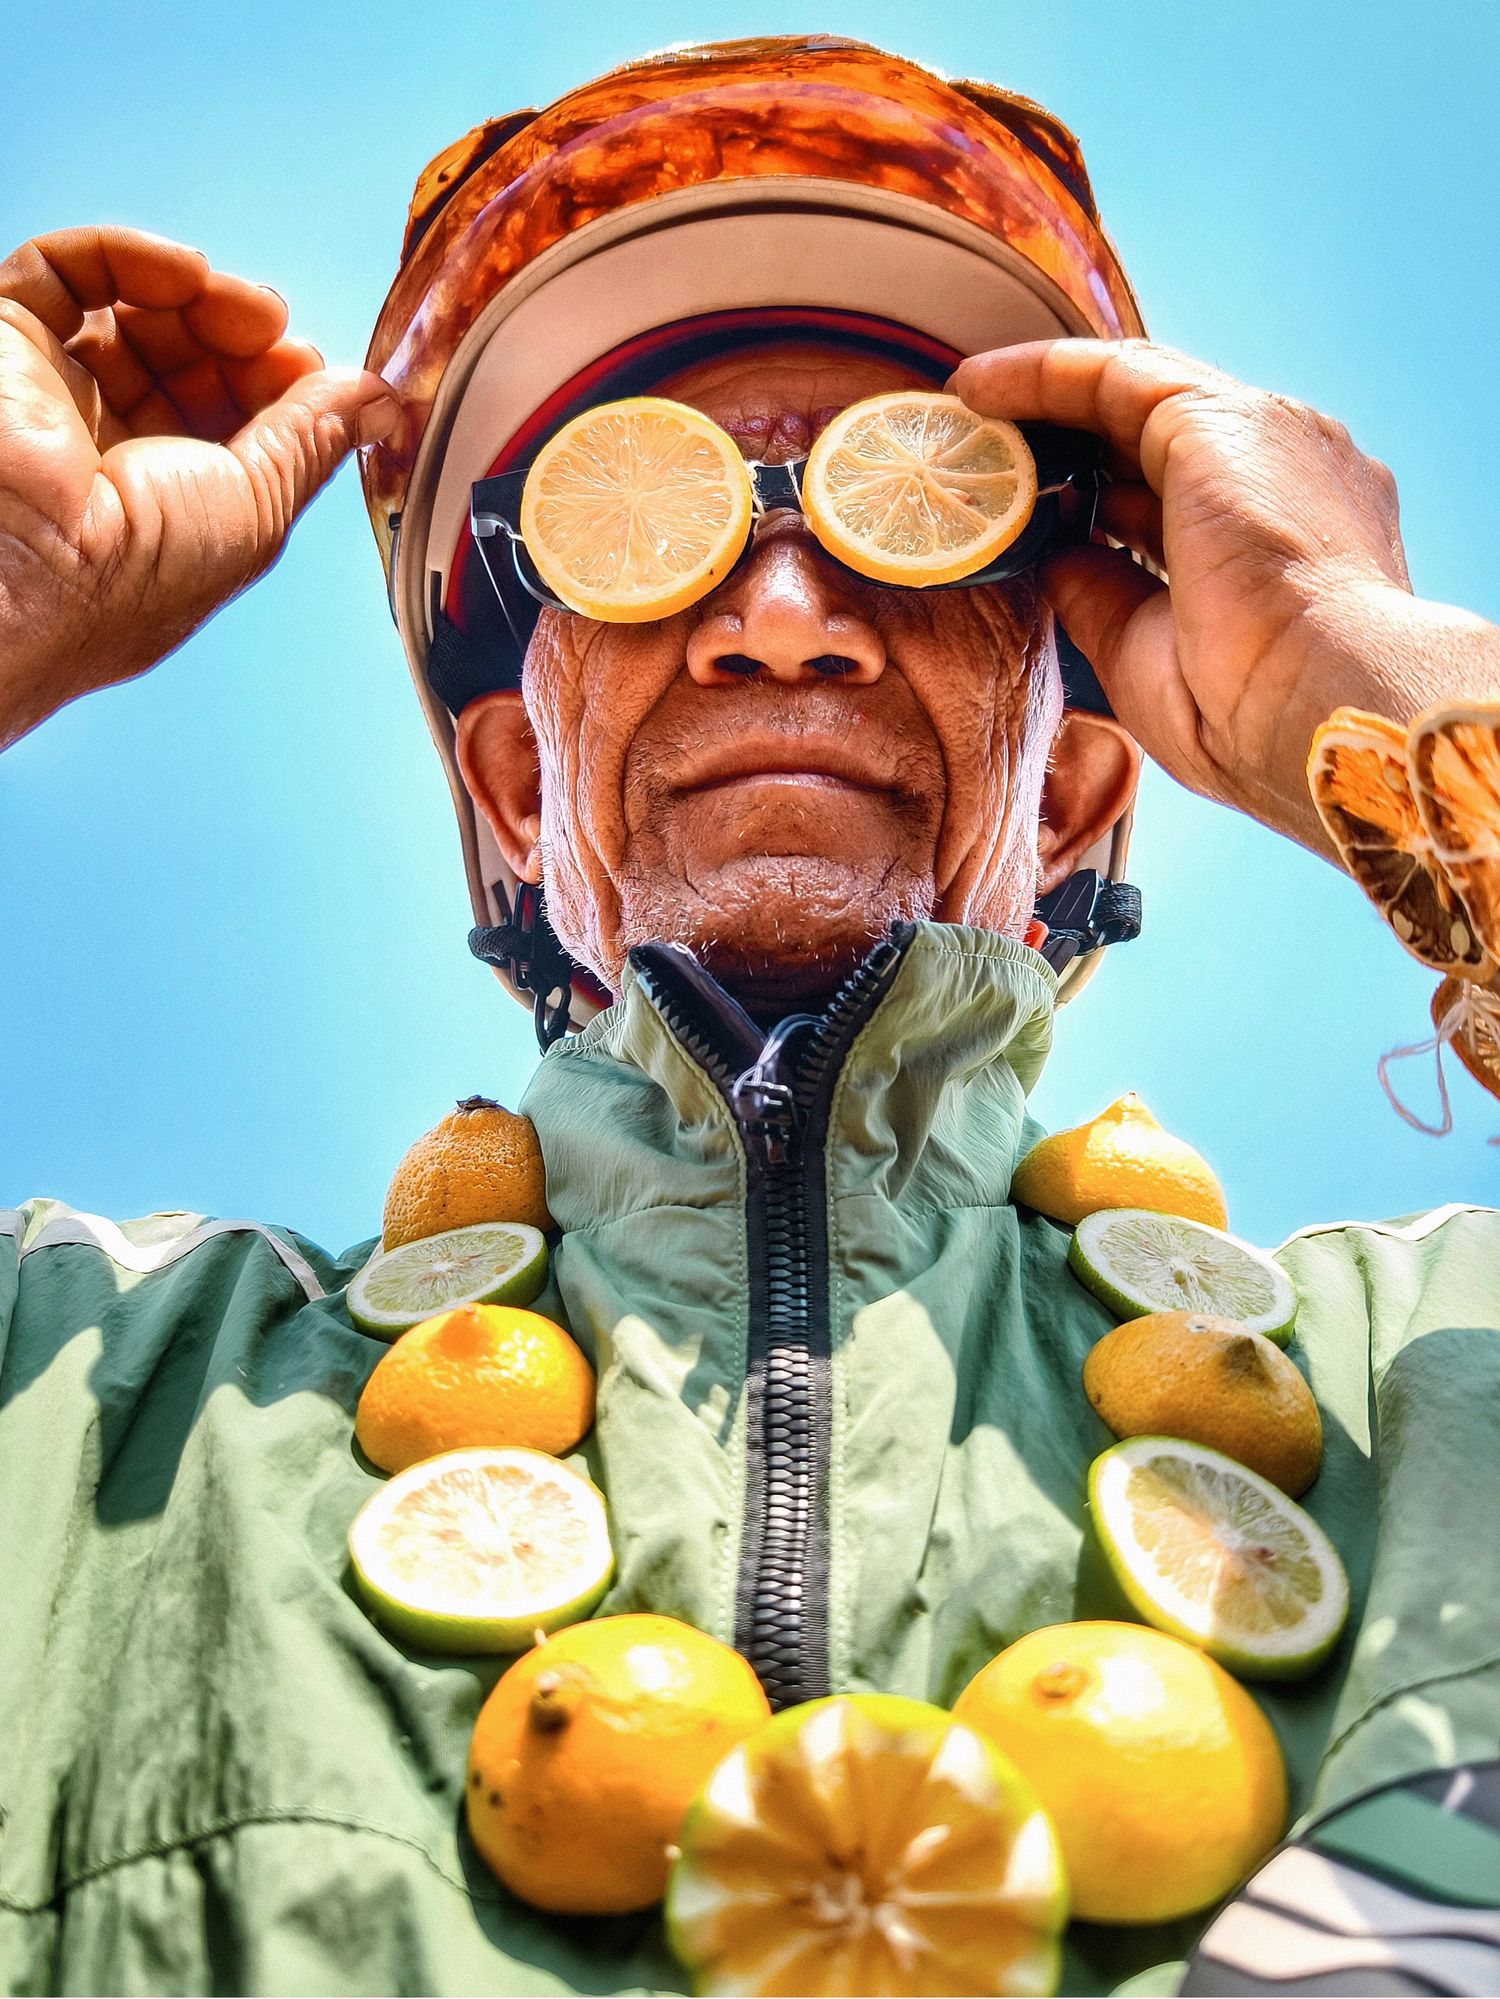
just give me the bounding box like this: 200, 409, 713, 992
468, 868, 1140, 1053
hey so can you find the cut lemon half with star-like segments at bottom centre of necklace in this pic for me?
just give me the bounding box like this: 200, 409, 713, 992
666, 1695, 1066, 1995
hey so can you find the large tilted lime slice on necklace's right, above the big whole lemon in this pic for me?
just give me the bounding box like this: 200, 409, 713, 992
1088, 1437, 1348, 1679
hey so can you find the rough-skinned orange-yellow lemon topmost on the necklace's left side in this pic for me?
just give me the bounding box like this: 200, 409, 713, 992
380, 1097, 552, 1249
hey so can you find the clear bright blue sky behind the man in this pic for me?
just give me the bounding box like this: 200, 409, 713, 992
0, 0, 1500, 1247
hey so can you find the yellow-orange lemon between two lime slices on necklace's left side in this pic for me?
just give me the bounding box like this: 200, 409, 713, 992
354, 1305, 594, 1471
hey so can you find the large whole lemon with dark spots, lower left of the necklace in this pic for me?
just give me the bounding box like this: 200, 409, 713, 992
466, 1615, 770, 1915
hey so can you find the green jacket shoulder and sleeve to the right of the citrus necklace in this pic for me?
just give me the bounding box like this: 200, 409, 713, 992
1282, 1207, 1500, 1811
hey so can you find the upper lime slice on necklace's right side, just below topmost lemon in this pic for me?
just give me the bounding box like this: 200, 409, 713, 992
1068, 1207, 1296, 1347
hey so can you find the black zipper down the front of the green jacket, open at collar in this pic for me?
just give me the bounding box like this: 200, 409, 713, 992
632, 924, 912, 1707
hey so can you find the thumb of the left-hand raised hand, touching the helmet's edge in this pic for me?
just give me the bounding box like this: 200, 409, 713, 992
228, 368, 400, 560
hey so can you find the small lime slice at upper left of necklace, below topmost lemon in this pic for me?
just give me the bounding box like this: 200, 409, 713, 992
348, 1221, 546, 1339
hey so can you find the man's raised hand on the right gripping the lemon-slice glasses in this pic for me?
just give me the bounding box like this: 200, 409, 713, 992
950, 340, 1496, 852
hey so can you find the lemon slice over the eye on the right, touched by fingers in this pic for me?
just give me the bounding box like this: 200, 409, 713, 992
802, 390, 1036, 588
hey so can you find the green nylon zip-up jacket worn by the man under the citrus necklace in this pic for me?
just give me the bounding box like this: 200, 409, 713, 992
0, 926, 1500, 1993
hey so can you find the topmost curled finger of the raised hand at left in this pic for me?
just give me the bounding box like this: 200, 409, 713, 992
0, 228, 210, 340
